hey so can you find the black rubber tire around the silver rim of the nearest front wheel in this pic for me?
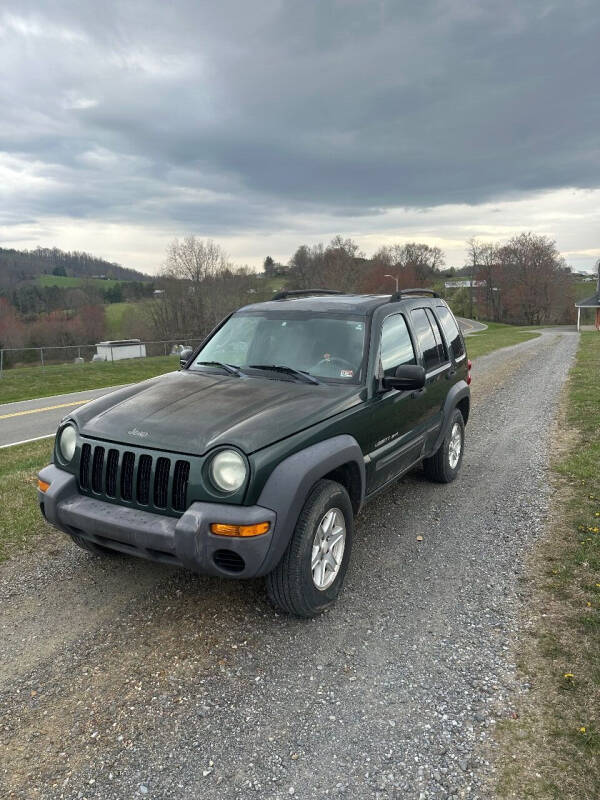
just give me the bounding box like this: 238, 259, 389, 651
266, 480, 354, 617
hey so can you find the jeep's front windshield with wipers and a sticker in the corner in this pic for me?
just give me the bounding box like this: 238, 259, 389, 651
189, 311, 365, 383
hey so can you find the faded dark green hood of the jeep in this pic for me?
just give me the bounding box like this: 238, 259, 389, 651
69, 370, 361, 455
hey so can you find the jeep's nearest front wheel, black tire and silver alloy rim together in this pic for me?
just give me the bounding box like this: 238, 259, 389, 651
266, 480, 354, 617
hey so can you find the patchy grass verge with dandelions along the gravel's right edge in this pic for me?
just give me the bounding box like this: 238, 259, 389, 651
499, 331, 600, 800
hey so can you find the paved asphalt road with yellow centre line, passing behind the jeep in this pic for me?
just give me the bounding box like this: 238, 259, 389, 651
0, 318, 487, 448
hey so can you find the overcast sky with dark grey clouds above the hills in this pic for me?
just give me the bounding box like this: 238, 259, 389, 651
0, 0, 600, 272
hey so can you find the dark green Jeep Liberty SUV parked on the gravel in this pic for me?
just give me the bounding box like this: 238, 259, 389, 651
38, 289, 471, 617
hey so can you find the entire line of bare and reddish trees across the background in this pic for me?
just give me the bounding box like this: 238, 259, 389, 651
0, 228, 574, 360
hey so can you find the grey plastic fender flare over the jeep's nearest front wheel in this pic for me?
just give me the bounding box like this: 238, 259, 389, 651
257, 434, 366, 574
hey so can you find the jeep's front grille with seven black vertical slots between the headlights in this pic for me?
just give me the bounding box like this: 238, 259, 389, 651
79, 442, 190, 512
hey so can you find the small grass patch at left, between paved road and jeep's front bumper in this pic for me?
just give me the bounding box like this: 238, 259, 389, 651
0, 439, 54, 561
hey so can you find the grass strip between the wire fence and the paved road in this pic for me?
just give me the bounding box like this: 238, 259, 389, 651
0, 356, 179, 406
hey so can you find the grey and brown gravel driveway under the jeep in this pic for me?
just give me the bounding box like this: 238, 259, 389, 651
0, 333, 577, 800
